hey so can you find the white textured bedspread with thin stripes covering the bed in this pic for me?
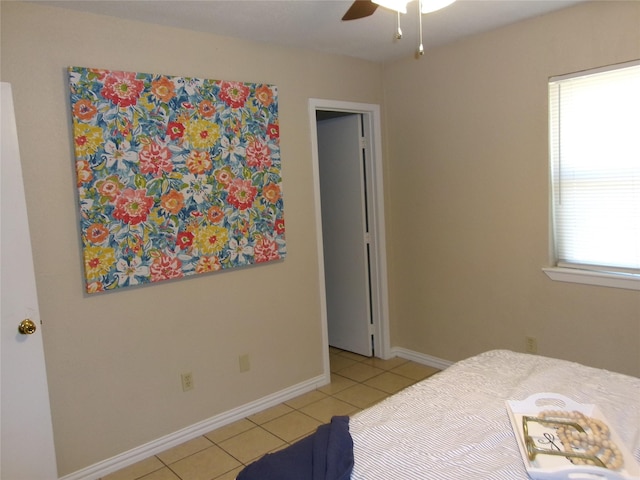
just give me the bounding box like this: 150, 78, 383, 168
349, 350, 640, 480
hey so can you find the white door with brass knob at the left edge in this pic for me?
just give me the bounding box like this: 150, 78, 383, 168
0, 82, 58, 480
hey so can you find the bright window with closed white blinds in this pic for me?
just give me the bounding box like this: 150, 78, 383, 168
545, 61, 640, 290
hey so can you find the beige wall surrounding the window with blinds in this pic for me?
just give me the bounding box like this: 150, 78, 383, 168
384, 2, 640, 376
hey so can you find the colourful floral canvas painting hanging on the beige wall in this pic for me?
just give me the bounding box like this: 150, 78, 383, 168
69, 67, 286, 293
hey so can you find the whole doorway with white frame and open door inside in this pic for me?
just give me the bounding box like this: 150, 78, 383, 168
309, 99, 390, 371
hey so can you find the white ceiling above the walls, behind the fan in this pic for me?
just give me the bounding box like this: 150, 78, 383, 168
33, 0, 585, 62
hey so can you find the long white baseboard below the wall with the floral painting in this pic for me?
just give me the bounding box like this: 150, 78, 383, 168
59, 373, 331, 480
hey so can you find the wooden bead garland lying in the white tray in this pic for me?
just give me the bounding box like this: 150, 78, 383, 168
538, 410, 624, 470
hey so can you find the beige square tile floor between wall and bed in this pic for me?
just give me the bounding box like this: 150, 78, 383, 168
102, 347, 438, 480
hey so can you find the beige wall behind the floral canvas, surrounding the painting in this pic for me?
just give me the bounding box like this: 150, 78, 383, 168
1, 1, 382, 475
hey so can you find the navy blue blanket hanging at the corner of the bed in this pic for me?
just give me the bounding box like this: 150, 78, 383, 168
236, 416, 353, 480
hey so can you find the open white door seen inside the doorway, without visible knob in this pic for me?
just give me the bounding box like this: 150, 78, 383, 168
317, 114, 373, 356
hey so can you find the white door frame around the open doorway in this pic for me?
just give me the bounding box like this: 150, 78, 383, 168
309, 98, 391, 375
